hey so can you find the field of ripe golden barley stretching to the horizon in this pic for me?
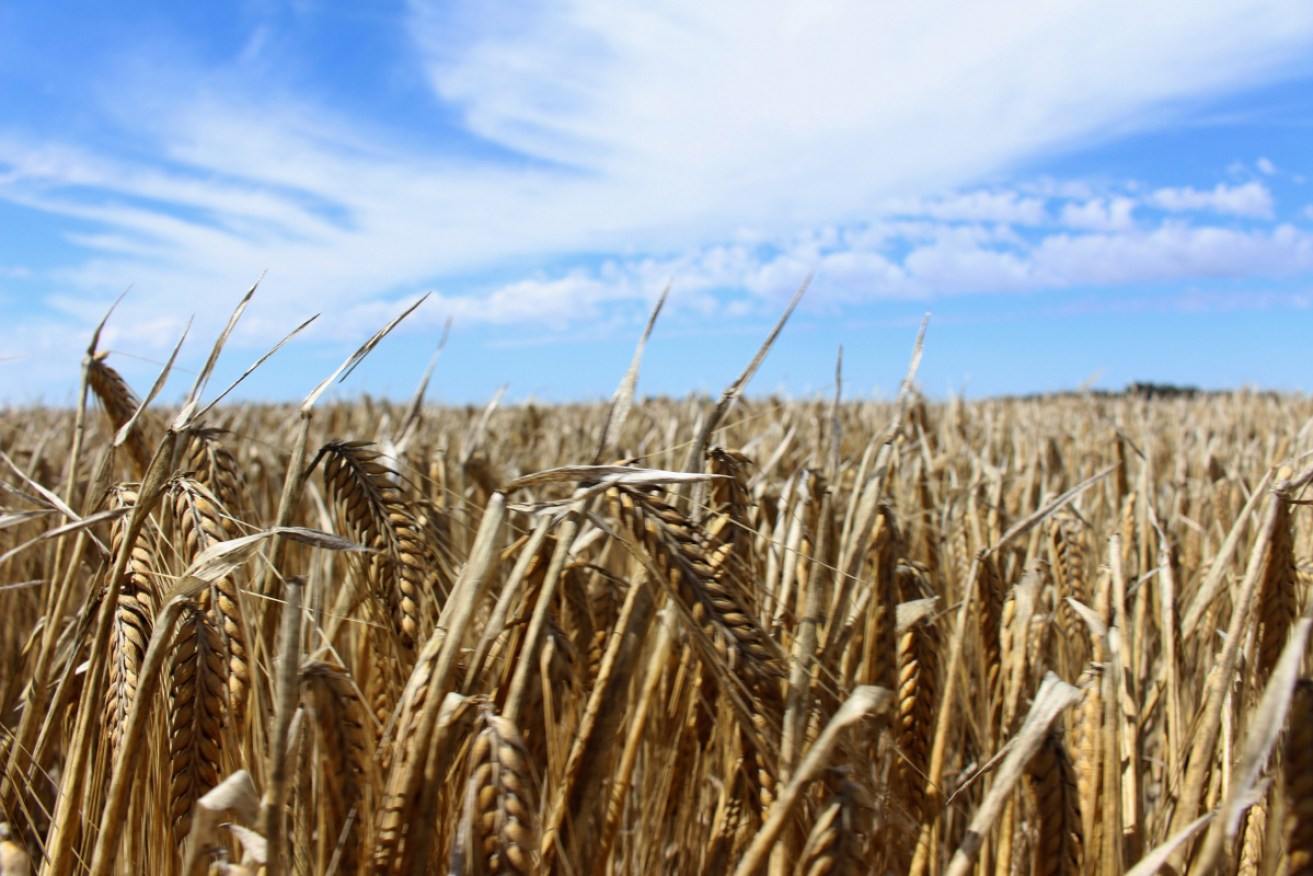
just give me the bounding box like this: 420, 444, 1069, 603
0, 307, 1313, 876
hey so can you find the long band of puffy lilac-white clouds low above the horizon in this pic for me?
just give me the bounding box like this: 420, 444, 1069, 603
433, 210, 1313, 309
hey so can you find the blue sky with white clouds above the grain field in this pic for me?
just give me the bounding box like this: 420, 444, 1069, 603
0, 0, 1313, 403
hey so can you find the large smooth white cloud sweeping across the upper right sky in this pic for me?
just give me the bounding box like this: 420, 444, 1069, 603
412, 0, 1313, 198
